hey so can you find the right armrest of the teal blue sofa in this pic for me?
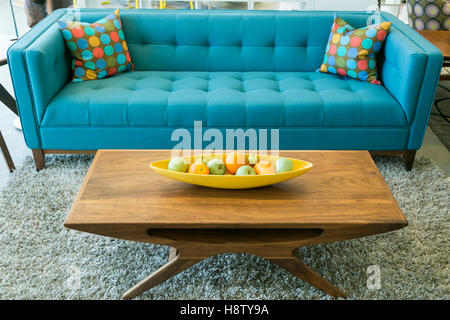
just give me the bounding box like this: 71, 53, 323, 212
381, 12, 443, 150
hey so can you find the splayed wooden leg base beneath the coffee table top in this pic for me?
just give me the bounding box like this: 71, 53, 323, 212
111, 229, 352, 299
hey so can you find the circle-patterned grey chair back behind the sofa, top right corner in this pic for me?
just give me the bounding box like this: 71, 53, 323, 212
407, 0, 450, 31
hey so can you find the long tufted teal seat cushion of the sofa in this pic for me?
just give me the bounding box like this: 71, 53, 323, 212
41, 71, 408, 128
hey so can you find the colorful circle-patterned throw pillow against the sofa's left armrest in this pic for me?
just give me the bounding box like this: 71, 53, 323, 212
57, 9, 134, 82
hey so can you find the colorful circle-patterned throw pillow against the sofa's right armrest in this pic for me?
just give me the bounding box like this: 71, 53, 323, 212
319, 17, 392, 84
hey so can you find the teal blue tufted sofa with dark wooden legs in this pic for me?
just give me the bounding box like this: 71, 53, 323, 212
8, 9, 442, 170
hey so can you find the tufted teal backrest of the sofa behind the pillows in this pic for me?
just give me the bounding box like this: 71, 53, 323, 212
76, 10, 370, 71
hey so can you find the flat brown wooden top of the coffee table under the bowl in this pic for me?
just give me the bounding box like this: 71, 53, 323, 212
64, 150, 407, 231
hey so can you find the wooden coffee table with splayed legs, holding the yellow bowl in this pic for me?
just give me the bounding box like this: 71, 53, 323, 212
64, 150, 407, 299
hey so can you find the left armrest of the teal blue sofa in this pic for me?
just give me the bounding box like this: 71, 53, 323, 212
8, 10, 71, 149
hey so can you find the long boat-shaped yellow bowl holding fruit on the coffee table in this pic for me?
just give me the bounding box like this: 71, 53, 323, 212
150, 154, 313, 189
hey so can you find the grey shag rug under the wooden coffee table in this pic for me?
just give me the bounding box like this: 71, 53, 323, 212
0, 156, 450, 299
